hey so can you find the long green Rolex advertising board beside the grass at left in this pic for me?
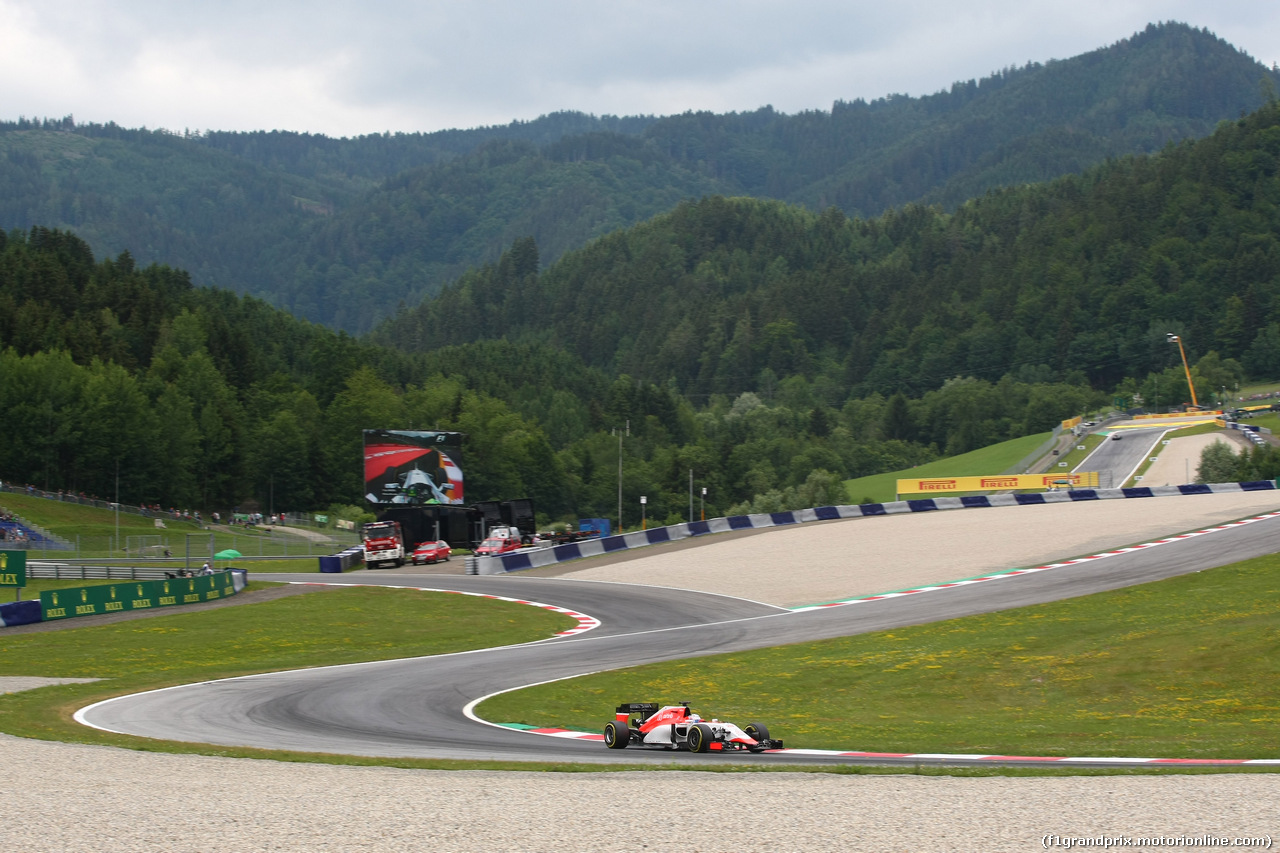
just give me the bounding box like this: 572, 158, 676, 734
40, 571, 238, 621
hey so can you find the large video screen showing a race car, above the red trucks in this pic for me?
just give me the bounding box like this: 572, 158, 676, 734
365, 429, 463, 506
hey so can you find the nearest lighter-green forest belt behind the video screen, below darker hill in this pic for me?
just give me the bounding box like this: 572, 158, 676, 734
0, 228, 1094, 525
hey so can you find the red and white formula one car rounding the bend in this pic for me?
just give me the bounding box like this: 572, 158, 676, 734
604, 702, 782, 752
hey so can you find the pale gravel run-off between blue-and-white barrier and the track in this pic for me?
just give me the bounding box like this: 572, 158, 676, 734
562, 491, 1280, 607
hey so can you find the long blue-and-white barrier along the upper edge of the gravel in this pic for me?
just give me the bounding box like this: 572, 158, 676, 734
467, 480, 1277, 575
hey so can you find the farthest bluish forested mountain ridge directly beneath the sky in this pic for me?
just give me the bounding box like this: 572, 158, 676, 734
0, 23, 1276, 332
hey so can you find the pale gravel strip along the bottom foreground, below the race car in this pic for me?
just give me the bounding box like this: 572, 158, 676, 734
0, 735, 1280, 853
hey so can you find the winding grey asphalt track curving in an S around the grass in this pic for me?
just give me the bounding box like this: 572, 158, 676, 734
78, 507, 1280, 765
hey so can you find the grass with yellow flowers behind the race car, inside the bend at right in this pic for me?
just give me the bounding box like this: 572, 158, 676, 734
477, 555, 1280, 758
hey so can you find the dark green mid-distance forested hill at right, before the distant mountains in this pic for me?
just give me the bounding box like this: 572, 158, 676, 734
376, 101, 1280, 398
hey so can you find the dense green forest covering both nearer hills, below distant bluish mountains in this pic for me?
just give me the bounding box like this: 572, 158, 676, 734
10, 92, 1280, 525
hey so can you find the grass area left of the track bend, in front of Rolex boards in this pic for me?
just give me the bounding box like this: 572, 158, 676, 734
0, 584, 576, 756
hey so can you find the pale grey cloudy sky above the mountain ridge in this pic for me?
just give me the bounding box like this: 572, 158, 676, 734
0, 0, 1280, 136
